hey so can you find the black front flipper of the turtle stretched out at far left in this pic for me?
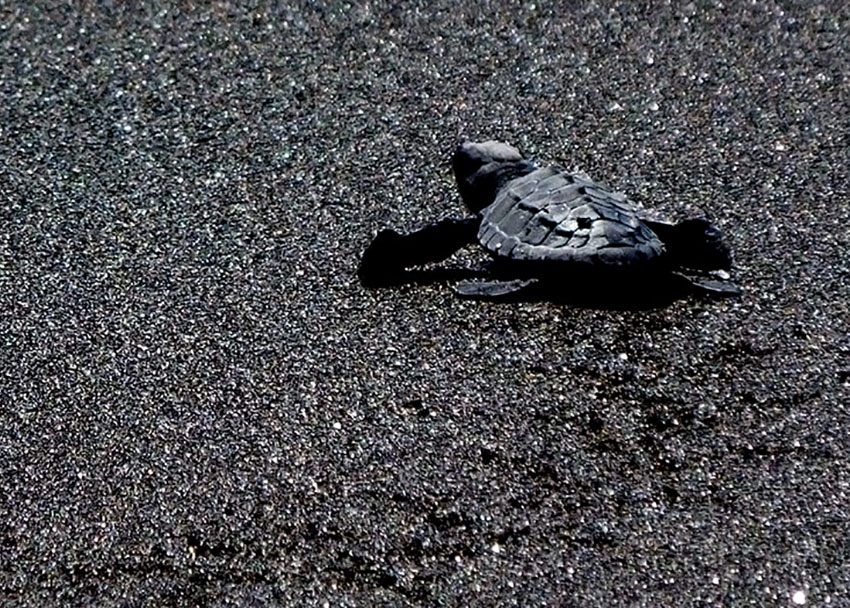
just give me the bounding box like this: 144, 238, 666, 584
357, 217, 481, 287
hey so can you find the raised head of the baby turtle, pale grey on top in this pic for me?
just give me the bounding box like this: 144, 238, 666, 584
452, 141, 536, 213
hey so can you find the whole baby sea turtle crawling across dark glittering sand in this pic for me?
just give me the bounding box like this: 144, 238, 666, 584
358, 141, 740, 301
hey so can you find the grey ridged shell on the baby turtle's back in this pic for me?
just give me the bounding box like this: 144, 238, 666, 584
478, 166, 664, 266
